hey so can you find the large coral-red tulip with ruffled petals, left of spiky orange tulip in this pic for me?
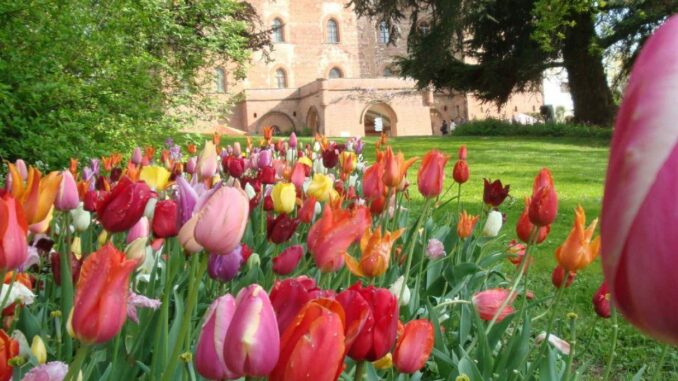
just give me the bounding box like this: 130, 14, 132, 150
307, 204, 371, 272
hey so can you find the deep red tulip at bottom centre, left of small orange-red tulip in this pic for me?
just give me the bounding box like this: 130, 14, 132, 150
336, 283, 398, 361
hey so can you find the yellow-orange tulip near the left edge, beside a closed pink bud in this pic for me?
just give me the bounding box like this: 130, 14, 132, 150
18, 167, 62, 225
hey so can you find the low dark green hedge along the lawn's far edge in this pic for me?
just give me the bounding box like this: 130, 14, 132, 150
452, 119, 612, 139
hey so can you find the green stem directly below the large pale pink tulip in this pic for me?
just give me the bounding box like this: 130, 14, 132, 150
162, 254, 207, 381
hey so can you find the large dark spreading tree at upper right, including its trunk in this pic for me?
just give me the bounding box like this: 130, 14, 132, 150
351, 0, 678, 126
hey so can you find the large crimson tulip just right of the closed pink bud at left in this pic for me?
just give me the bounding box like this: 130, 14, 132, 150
97, 177, 151, 233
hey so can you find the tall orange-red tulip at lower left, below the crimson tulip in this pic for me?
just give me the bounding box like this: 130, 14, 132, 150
72, 243, 137, 344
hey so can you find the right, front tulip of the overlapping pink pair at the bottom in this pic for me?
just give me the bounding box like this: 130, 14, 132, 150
224, 284, 280, 377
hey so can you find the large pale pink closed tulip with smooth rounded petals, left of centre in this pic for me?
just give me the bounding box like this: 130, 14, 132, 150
194, 187, 249, 254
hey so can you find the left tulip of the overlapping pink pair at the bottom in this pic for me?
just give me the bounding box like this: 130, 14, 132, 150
194, 294, 242, 380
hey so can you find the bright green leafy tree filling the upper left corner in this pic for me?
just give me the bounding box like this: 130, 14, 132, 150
0, 0, 268, 165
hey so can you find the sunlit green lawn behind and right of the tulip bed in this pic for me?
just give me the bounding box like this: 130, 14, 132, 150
216, 137, 678, 380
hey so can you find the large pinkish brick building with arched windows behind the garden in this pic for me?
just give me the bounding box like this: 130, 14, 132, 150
202, 0, 543, 136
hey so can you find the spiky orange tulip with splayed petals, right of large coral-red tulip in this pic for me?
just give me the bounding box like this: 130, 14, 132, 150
344, 228, 404, 278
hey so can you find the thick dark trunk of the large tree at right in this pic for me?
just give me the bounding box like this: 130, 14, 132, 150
562, 12, 615, 127
